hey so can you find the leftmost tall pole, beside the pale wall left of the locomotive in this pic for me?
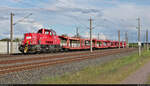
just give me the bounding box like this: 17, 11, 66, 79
10, 13, 14, 54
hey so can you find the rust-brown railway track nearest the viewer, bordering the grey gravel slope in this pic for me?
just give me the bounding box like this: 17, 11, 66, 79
0, 49, 136, 75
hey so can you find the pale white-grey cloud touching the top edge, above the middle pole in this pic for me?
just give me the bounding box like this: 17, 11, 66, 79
42, 0, 100, 14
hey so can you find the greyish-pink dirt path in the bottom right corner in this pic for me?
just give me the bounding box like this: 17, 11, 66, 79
121, 59, 150, 84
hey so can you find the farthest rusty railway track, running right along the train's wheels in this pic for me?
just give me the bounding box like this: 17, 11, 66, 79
0, 49, 122, 62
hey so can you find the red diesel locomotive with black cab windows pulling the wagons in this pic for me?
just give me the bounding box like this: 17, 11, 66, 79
19, 29, 61, 53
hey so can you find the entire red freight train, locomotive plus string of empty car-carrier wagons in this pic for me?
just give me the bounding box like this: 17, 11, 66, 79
19, 28, 126, 53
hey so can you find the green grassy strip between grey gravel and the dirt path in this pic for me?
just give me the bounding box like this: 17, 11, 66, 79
39, 49, 150, 84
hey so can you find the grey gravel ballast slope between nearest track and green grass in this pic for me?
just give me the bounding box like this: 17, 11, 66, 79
0, 50, 137, 84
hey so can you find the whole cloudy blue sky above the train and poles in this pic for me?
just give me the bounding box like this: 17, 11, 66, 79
0, 0, 150, 42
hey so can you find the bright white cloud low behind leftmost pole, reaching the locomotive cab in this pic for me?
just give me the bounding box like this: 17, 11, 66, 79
0, 15, 43, 38
